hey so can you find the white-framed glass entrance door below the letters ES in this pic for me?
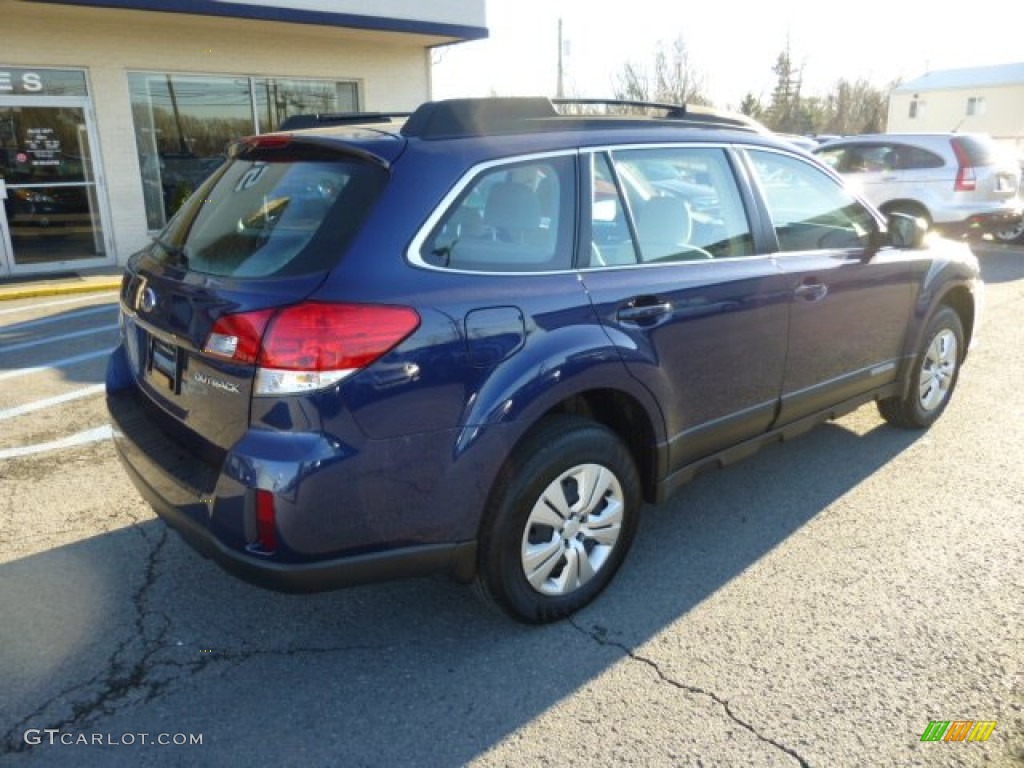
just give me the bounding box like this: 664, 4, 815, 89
0, 101, 106, 271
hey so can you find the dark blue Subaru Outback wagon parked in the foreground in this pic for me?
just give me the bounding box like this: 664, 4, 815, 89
108, 98, 981, 622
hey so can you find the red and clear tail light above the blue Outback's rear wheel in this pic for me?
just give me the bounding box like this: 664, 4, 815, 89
204, 302, 420, 394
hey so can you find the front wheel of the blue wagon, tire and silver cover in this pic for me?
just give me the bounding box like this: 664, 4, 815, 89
879, 306, 965, 429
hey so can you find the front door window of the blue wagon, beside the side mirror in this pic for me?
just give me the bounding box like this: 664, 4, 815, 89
750, 150, 877, 252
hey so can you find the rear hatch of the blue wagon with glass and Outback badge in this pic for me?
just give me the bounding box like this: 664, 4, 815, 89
121, 134, 404, 466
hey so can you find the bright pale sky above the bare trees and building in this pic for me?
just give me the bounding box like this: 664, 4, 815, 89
433, 0, 1024, 109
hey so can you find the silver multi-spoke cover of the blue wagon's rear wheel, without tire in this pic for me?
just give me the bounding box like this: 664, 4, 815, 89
521, 464, 625, 596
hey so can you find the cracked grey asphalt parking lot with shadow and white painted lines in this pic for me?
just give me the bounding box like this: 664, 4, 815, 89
0, 244, 1024, 768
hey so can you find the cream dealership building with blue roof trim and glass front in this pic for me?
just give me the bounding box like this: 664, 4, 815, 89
0, 0, 487, 278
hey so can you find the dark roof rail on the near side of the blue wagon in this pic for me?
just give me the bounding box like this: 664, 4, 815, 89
401, 96, 770, 139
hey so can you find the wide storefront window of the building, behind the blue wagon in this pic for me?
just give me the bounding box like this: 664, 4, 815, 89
128, 73, 357, 229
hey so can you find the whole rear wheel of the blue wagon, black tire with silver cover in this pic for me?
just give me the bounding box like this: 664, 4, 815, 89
475, 415, 643, 624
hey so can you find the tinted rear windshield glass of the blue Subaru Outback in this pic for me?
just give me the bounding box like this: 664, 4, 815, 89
157, 147, 387, 278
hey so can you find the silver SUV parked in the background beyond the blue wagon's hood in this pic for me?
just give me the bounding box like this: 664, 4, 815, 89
815, 133, 1022, 236
